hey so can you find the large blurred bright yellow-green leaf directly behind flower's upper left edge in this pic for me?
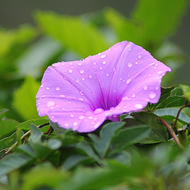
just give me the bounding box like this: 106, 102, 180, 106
35, 11, 108, 58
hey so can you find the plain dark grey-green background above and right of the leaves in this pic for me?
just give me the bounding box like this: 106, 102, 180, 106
0, 0, 190, 84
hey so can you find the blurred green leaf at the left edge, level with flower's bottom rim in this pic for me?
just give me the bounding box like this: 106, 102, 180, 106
0, 119, 18, 139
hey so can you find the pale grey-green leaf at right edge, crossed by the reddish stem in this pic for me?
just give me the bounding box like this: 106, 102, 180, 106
154, 108, 190, 124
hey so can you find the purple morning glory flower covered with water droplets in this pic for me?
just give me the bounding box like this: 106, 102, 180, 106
36, 41, 171, 132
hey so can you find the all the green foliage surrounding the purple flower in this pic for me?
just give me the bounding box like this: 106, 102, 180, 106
0, 0, 190, 190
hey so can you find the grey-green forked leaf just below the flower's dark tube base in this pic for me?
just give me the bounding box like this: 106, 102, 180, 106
88, 122, 125, 158
